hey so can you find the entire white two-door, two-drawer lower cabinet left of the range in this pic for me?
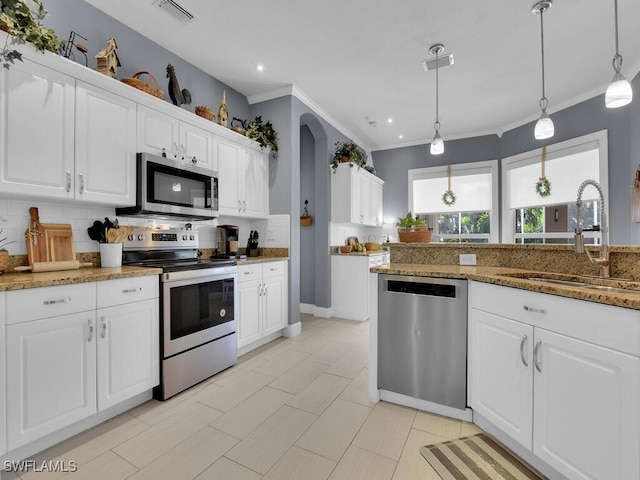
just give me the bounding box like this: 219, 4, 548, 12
6, 276, 159, 451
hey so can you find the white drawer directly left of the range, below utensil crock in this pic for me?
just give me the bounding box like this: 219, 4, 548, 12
97, 275, 160, 308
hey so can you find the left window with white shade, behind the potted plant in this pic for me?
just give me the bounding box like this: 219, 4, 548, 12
409, 160, 498, 243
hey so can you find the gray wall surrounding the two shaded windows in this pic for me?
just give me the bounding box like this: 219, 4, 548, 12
373, 75, 640, 245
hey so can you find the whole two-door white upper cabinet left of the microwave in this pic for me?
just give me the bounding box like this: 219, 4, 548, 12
0, 60, 136, 205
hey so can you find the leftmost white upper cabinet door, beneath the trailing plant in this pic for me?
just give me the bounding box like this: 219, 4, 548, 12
0, 60, 75, 198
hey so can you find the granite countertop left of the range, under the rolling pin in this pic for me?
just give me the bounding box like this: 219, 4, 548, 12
0, 266, 162, 292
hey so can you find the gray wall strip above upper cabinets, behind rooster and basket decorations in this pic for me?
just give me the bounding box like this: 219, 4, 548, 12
42, 0, 249, 121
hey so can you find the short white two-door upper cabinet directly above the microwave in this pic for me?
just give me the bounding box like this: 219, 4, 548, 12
137, 105, 218, 171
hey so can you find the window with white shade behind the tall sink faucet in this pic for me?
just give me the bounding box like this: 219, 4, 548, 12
502, 130, 609, 243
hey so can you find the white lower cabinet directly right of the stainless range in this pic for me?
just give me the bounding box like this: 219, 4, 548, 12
238, 262, 288, 348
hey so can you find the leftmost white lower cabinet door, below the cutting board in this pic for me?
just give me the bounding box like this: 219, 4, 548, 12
7, 310, 97, 451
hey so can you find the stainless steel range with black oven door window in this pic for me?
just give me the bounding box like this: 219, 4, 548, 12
122, 228, 238, 400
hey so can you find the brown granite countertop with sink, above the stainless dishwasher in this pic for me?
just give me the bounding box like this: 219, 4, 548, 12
371, 263, 640, 310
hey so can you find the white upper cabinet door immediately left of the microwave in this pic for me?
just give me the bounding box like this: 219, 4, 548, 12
75, 81, 136, 205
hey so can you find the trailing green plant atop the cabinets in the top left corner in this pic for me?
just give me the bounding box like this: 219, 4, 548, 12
0, 0, 60, 68
